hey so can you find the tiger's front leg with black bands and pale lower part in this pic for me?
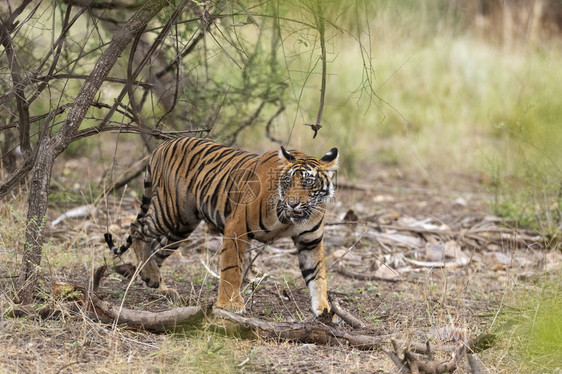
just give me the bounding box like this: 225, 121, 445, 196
293, 232, 330, 316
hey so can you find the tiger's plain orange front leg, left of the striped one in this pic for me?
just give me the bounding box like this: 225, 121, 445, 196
217, 230, 247, 313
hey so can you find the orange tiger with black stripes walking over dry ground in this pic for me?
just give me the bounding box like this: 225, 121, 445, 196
104, 137, 339, 318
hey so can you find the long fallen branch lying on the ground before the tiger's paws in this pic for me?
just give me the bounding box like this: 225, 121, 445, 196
5, 266, 389, 350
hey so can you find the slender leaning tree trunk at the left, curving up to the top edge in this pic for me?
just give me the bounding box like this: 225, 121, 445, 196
18, 0, 168, 304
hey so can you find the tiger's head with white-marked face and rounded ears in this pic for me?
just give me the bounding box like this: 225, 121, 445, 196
277, 147, 338, 224
